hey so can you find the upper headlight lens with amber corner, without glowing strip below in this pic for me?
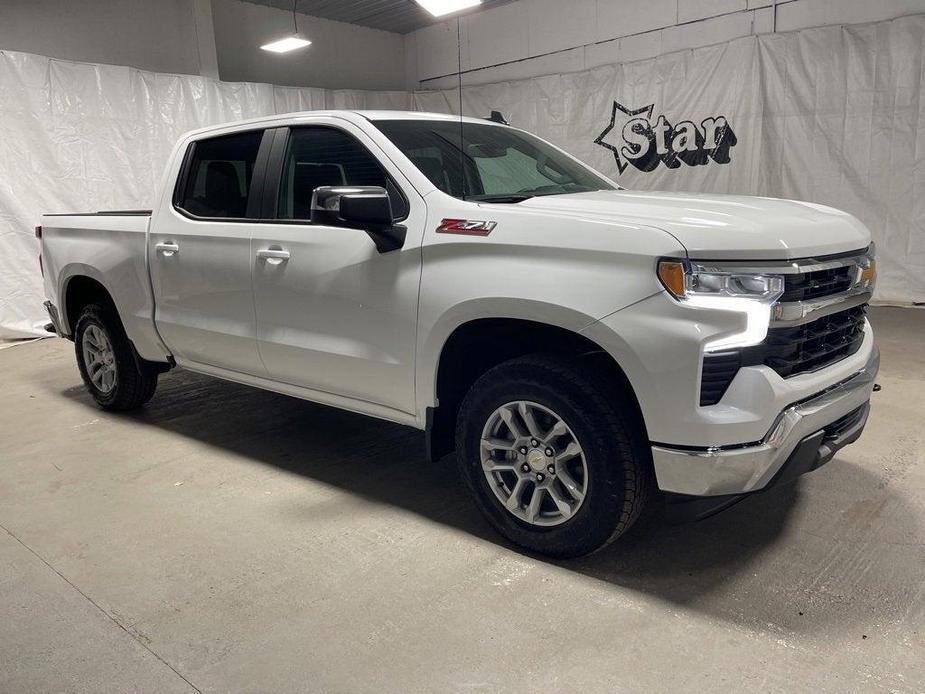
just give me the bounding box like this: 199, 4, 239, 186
658, 260, 784, 304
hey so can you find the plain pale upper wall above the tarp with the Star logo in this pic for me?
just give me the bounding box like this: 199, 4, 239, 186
405, 0, 925, 89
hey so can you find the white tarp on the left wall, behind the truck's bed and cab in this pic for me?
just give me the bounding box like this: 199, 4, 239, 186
0, 51, 412, 339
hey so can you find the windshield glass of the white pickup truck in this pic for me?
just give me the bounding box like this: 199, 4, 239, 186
375, 120, 618, 203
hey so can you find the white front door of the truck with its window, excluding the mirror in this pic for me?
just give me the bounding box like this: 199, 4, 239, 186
253, 119, 425, 413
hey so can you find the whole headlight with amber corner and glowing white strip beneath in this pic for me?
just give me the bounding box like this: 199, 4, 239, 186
658, 260, 784, 352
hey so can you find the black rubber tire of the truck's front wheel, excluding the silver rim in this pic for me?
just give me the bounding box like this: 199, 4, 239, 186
456, 355, 653, 557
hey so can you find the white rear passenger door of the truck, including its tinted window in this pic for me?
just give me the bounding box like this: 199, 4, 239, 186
148, 130, 272, 375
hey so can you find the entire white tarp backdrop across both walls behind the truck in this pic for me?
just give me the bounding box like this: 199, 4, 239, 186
0, 15, 925, 338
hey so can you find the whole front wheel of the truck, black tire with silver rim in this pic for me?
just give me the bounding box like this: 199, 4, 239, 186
456, 355, 651, 557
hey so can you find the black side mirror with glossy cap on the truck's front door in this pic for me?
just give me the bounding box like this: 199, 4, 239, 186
311, 186, 407, 253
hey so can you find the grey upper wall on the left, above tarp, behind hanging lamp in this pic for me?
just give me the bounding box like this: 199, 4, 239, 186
0, 0, 408, 90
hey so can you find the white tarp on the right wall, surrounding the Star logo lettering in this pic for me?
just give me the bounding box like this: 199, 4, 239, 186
415, 15, 925, 303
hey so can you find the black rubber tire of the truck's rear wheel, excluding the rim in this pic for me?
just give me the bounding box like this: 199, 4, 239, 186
74, 304, 158, 411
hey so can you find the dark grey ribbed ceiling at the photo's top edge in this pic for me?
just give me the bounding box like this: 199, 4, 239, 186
247, 0, 513, 34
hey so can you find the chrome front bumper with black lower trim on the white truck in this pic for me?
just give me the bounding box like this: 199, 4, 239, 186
652, 347, 880, 497
